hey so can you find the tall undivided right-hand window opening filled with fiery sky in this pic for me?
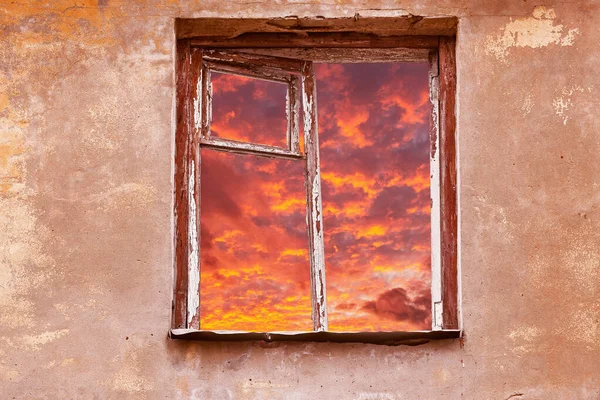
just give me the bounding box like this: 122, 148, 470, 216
315, 63, 431, 331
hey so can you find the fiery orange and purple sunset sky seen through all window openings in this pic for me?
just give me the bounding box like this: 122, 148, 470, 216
200, 63, 431, 331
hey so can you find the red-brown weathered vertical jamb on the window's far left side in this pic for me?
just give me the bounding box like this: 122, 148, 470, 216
171, 40, 190, 328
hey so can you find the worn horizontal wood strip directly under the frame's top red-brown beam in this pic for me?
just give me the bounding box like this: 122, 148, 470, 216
226, 47, 431, 64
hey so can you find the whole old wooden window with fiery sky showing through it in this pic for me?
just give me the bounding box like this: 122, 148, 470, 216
172, 28, 459, 342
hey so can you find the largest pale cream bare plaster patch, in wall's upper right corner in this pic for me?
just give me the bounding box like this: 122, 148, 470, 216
485, 6, 579, 63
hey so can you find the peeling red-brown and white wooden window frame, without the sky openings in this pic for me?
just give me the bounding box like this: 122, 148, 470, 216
170, 33, 462, 344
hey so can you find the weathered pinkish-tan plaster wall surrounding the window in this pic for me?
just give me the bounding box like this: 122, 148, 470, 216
0, 0, 600, 399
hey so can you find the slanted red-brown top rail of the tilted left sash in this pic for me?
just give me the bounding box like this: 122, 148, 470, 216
203, 50, 302, 74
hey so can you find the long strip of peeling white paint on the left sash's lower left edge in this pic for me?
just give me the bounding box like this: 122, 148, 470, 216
187, 161, 200, 325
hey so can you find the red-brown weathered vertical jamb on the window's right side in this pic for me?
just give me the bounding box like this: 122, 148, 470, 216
439, 37, 458, 329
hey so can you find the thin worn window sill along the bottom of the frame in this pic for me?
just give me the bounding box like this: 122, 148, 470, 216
169, 329, 462, 346
